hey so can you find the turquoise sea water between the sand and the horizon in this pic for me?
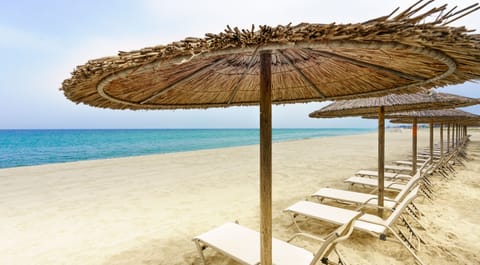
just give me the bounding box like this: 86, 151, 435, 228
0, 128, 374, 168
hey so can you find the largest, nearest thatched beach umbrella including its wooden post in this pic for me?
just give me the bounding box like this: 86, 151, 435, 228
62, 1, 480, 265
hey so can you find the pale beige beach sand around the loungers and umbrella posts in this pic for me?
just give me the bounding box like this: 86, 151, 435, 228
0, 129, 480, 265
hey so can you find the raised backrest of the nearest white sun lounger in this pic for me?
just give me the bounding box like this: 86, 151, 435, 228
310, 212, 363, 265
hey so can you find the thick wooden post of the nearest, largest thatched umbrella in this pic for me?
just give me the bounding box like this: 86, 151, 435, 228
260, 51, 272, 265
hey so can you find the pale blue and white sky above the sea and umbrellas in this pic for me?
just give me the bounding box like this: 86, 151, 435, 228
0, 0, 480, 129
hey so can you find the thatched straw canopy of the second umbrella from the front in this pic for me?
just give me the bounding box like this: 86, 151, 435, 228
309, 91, 480, 118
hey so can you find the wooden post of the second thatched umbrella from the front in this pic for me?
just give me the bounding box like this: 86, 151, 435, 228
378, 106, 385, 217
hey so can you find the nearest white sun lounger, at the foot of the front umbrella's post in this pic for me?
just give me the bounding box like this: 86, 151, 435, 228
193, 209, 362, 265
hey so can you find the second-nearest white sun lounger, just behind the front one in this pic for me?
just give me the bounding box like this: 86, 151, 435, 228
284, 186, 424, 265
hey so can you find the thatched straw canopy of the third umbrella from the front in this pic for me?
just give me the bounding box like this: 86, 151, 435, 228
362, 109, 480, 123
